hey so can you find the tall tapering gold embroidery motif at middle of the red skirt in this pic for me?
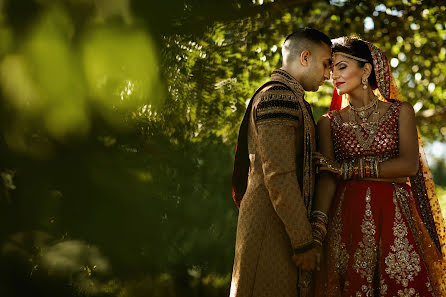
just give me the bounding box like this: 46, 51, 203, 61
353, 188, 377, 296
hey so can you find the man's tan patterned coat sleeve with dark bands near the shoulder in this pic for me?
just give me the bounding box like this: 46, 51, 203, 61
255, 91, 313, 253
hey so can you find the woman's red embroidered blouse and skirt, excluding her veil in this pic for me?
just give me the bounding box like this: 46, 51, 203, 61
318, 101, 441, 297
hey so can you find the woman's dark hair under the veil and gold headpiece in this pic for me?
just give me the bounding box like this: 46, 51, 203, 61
331, 36, 378, 90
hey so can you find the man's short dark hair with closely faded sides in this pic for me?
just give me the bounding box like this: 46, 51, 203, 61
282, 27, 332, 62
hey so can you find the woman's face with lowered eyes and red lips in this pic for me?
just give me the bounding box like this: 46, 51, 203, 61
332, 54, 364, 95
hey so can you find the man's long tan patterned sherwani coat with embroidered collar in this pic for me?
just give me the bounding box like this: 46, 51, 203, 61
230, 70, 315, 297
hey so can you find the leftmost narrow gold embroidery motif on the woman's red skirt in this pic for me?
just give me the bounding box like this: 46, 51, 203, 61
330, 188, 349, 275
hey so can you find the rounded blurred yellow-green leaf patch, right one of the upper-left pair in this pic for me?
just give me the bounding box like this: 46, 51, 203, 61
82, 27, 163, 124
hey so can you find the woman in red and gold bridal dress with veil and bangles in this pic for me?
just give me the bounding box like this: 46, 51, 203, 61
312, 37, 446, 297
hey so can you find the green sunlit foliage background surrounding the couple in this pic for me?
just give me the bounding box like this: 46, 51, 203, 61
0, 0, 446, 297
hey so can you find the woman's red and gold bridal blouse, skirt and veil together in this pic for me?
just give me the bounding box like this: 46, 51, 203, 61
316, 43, 446, 297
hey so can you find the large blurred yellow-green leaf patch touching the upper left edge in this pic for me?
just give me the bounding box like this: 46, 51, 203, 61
0, 9, 89, 151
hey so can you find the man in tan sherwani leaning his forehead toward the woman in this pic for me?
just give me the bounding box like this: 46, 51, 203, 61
230, 28, 331, 297
